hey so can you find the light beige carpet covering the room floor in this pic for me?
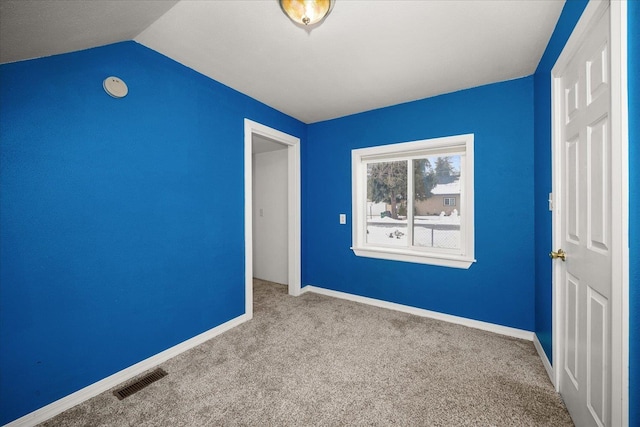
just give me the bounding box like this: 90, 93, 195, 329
43, 280, 573, 426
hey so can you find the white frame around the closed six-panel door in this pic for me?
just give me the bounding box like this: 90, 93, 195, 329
551, 0, 629, 426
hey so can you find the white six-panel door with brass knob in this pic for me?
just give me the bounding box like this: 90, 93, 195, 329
554, 8, 612, 426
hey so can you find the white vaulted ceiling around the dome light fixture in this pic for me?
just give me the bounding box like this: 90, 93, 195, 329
0, 0, 564, 123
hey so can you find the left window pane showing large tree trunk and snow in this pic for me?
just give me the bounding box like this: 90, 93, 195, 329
366, 161, 407, 247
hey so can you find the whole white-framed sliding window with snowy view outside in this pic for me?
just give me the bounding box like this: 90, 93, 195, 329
352, 134, 475, 268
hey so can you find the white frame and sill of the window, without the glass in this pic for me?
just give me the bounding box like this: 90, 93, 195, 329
351, 134, 476, 269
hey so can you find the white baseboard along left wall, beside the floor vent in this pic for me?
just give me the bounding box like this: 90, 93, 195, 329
5, 314, 249, 427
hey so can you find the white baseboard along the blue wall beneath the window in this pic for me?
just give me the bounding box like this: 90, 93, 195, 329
302, 285, 534, 341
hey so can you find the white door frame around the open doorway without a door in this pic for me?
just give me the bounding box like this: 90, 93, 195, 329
244, 118, 302, 320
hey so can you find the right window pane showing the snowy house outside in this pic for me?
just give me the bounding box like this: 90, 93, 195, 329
413, 155, 462, 249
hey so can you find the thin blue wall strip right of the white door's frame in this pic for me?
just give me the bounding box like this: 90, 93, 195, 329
627, 1, 640, 426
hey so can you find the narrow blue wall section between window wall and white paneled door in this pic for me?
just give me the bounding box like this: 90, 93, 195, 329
534, 0, 588, 363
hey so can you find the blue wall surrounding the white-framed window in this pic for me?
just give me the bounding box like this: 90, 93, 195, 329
302, 77, 534, 331
